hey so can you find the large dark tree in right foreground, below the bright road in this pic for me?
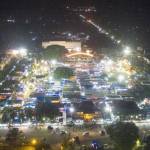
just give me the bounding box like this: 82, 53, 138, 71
107, 122, 139, 150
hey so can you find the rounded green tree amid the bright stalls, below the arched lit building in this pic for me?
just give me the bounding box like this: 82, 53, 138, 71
54, 67, 74, 80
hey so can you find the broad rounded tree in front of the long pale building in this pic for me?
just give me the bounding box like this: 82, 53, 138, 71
42, 45, 67, 60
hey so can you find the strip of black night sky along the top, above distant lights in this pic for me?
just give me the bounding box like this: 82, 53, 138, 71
0, 0, 150, 9
